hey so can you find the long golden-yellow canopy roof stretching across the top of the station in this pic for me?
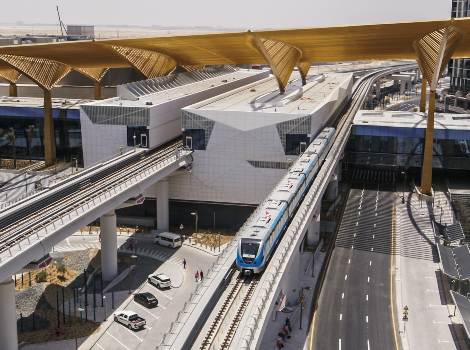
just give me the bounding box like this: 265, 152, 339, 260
0, 18, 470, 69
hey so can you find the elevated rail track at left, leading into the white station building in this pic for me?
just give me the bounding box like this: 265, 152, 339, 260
0, 140, 191, 270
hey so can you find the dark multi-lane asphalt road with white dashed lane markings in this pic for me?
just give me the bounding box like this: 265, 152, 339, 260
313, 189, 396, 350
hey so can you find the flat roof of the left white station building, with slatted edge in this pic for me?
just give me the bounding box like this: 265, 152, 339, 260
88, 69, 267, 108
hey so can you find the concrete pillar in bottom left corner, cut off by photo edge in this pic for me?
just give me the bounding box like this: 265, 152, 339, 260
0, 278, 18, 350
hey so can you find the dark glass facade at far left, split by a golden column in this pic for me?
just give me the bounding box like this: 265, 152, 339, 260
0, 107, 83, 163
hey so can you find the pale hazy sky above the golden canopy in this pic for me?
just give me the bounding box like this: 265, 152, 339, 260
0, 0, 451, 29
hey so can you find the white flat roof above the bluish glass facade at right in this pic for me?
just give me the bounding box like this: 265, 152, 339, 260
353, 110, 470, 130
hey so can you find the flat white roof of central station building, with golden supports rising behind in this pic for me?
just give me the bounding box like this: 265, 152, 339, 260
187, 72, 351, 115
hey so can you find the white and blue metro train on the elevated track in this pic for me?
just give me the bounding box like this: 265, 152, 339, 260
236, 127, 335, 274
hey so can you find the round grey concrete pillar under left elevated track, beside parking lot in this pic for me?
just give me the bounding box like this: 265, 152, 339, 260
100, 210, 117, 281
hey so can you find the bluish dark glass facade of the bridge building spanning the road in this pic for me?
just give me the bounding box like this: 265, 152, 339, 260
346, 125, 470, 170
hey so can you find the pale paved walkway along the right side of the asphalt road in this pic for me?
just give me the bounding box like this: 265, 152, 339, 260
395, 192, 460, 350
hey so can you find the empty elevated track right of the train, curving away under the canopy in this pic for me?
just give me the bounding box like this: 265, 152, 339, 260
234, 64, 416, 349
